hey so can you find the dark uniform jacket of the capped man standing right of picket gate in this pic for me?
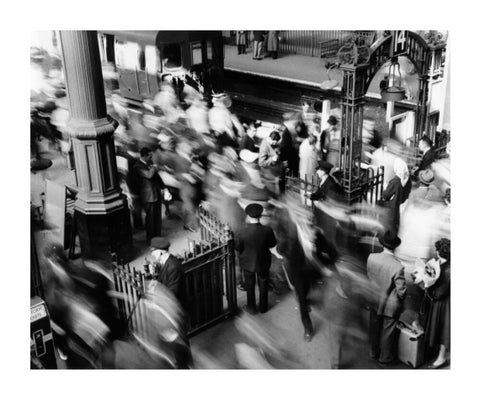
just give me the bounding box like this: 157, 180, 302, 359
235, 223, 277, 275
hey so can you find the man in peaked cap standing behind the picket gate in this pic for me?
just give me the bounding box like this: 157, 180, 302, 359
149, 237, 184, 305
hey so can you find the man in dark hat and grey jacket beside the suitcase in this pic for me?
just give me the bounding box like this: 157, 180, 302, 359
367, 231, 407, 364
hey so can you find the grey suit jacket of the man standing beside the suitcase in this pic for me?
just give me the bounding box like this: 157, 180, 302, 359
367, 252, 407, 318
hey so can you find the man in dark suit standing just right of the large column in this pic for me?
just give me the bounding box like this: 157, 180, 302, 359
133, 147, 165, 243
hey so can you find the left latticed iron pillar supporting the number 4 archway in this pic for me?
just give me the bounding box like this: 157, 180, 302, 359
339, 64, 368, 203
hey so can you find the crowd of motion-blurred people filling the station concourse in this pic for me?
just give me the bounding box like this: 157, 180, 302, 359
32, 47, 450, 368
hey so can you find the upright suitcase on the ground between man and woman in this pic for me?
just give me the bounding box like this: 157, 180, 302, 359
398, 323, 425, 368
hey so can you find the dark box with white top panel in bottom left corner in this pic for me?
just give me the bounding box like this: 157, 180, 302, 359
30, 296, 57, 369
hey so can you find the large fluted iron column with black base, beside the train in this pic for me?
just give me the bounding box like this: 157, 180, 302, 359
60, 31, 132, 260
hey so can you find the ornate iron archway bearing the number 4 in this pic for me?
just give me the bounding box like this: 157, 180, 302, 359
339, 30, 445, 202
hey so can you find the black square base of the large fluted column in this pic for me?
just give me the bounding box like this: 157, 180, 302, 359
75, 203, 133, 262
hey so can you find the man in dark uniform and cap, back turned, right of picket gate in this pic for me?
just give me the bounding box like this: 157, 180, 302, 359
235, 203, 277, 314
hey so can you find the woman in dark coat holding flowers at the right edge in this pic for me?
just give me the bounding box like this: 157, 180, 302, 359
425, 238, 450, 369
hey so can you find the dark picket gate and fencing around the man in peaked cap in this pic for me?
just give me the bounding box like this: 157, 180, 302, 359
113, 205, 237, 336
